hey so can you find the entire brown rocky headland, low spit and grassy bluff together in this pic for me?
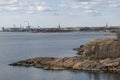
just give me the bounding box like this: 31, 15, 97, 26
9, 31, 120, 73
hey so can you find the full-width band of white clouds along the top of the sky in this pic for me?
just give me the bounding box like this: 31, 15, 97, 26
0, 0, 120, 14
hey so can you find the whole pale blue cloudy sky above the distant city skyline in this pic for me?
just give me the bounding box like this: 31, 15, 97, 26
0, 0, 120, 27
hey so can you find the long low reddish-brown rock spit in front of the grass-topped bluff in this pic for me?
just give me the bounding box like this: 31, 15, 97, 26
9, 56, 120, 72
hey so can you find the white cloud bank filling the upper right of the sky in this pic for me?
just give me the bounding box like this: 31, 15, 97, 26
61, 0, 120, 14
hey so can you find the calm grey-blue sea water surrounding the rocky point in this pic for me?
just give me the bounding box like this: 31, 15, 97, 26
0, 32, 120, 80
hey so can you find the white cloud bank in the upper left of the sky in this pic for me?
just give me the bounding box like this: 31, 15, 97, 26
0, 0, 53, 13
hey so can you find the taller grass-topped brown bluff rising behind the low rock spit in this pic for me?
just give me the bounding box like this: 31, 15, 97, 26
74, 38, 120, 59
